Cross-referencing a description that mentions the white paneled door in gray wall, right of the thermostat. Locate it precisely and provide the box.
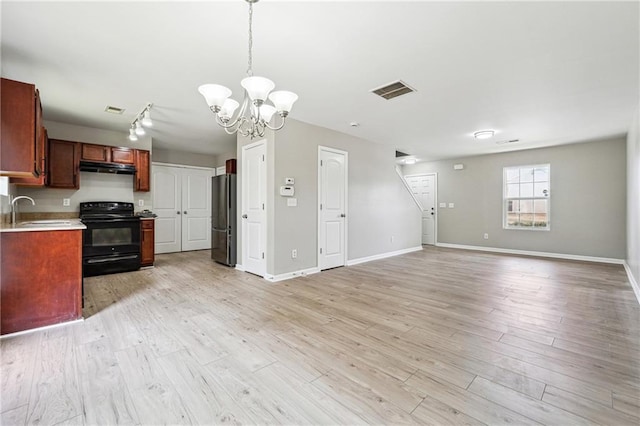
[318,147,348,270]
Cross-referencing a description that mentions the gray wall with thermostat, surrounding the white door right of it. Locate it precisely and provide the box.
[237,120,421,275]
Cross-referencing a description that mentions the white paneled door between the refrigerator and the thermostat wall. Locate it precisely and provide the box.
[242,141,267,276]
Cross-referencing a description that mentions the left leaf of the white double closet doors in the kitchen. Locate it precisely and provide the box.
[151,165,182,253]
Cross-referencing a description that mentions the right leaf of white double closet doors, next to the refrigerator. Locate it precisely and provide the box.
[182,168,214,251]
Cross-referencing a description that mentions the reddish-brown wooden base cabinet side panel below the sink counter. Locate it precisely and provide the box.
[0,230,82,334]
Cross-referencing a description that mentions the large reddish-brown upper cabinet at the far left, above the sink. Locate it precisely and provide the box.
[0,78,44,178]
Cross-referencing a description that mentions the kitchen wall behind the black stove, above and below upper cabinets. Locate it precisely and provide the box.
[11,121,155,213]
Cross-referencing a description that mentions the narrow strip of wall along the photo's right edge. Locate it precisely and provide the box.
[627,108,640,285]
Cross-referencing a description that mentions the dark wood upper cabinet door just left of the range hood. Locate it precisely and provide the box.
[47,139,81,189]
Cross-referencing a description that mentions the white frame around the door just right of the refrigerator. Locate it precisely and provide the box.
[241,138,269,278]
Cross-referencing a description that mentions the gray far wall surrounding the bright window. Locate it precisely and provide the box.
[402,138,627,259]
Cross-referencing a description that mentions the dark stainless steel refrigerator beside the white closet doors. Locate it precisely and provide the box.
[211,174,238,266]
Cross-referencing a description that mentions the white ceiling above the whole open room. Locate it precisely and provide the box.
[1,0,640,159]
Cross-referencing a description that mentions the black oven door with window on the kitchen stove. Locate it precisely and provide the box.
[82,217,140,258]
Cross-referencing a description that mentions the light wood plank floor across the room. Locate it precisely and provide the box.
[0,247,640,425]
